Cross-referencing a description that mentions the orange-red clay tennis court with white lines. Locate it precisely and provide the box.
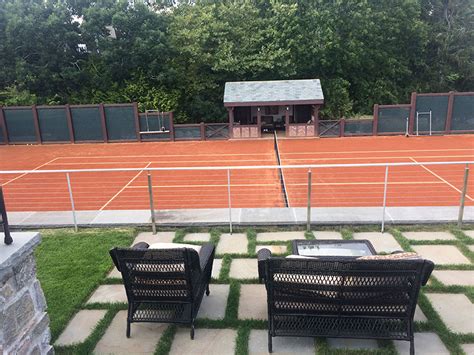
[0,135,474,211]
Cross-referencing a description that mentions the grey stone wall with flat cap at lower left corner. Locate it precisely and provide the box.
[0,233,54,354]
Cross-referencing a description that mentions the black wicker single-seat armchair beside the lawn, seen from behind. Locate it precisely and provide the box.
[110,242,215,339]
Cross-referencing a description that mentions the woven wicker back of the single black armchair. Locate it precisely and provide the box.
[111,248,201,302]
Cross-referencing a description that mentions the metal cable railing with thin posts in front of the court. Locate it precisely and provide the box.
[0,160,474,232]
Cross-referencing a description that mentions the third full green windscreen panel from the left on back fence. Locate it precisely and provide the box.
[71,107,104,142]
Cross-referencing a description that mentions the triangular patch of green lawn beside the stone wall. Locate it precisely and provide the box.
[35,229,135,341]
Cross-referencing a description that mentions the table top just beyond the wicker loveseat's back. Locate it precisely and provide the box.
[293,239,376,257]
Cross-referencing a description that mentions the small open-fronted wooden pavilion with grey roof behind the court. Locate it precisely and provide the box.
[224,79,324,138]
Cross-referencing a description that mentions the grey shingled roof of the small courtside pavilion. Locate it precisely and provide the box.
[224,79,324,106]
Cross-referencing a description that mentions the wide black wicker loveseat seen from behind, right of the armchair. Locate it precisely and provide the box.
[258,249,434,354]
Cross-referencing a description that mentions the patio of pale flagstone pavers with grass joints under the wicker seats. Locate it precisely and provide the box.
[51,231,474,355]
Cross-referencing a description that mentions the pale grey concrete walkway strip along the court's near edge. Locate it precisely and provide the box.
[8,206,474,228]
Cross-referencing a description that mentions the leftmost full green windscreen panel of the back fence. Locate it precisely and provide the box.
[3,108,36,143]
